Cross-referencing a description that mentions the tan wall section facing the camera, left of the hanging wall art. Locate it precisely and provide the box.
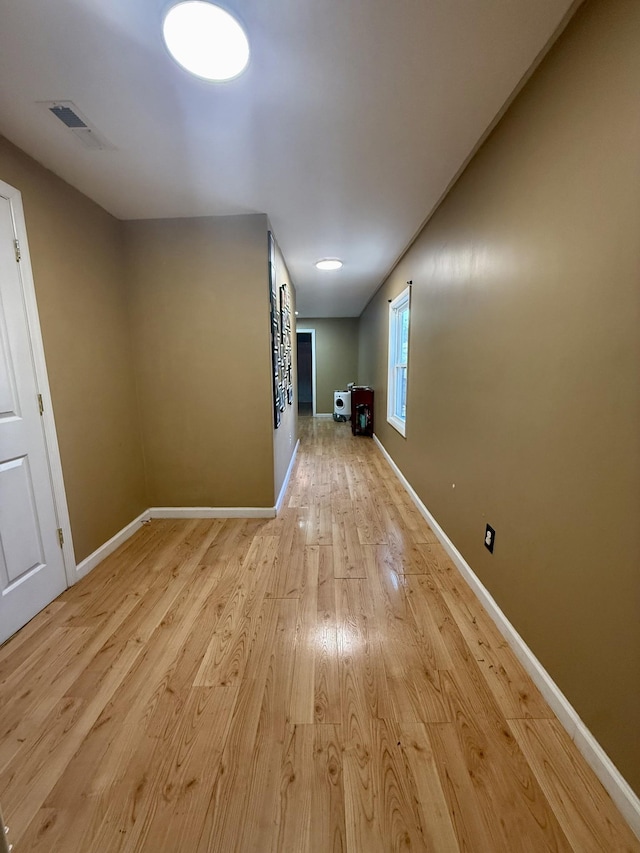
[125,215,274,507]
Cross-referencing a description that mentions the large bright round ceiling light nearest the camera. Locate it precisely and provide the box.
[162,0,249,81]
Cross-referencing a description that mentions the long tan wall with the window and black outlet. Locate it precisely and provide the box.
[359,0,640,793]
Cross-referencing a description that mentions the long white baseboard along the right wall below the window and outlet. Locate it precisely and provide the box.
[373,435,640,838]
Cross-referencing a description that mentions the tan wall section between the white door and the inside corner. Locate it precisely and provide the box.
[0,137,147,561]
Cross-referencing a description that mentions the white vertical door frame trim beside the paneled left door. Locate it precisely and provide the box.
[0,181,78,586]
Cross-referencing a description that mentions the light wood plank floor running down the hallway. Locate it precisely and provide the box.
[0,418,640,853]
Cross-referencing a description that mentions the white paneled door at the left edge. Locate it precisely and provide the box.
[0,194,67,642]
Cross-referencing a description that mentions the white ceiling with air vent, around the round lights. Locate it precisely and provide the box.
[0,0,572,317]
